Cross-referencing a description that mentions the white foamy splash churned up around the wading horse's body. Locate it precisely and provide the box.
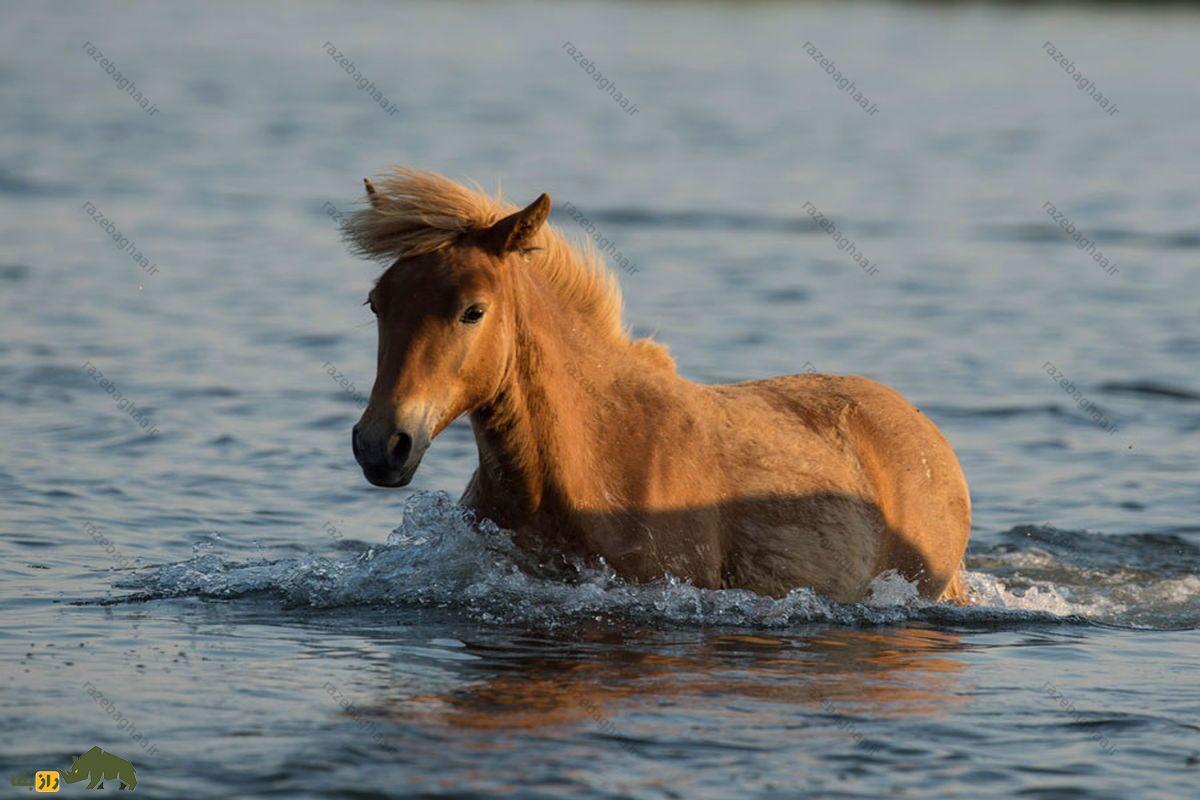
[108,492,1200,627]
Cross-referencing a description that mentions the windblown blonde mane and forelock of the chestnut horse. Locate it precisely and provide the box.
[343,167,674,366]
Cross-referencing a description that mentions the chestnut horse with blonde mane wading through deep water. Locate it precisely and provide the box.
[343,168,971,603]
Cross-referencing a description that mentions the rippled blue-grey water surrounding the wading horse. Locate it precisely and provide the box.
[0,2,1200,798]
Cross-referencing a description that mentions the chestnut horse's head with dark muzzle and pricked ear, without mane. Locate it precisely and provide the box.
[352,186,550,487]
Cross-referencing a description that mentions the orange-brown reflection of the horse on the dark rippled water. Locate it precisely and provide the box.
[417,628,964,728]
